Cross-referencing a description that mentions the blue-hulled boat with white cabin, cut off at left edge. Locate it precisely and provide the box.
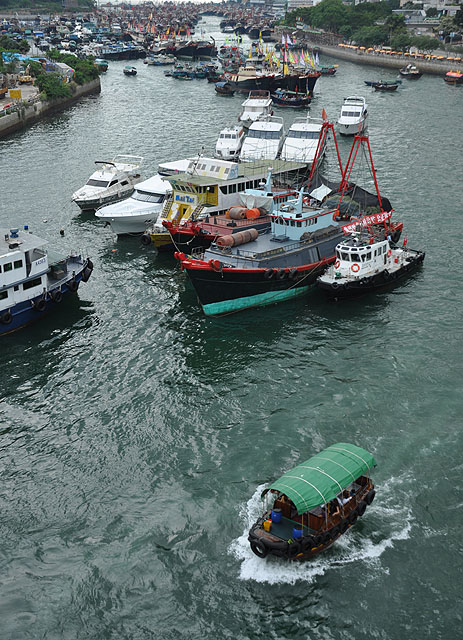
[0,226,93,334]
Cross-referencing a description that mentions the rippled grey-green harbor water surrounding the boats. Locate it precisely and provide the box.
[0,17,463,640]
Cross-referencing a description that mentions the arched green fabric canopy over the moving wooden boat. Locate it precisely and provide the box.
[268,442,376,514]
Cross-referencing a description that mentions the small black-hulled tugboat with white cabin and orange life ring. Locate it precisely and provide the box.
[317,225,425,300]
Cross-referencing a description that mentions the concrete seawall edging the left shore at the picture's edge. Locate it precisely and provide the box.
[0,78,101,139]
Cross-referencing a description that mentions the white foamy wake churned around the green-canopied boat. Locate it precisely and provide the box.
[229,478,412,584]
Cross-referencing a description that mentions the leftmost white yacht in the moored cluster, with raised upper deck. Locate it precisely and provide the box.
[72,155,143,210]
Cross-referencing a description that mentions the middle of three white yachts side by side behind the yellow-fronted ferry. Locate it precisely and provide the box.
[240,116,285,162]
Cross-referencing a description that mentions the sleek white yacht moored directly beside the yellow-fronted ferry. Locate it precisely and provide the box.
[95,174,171,235]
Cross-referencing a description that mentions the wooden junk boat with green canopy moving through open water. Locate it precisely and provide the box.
[248,442,376,560]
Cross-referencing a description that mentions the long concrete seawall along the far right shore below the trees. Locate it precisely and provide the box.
[307,42,463,76]
